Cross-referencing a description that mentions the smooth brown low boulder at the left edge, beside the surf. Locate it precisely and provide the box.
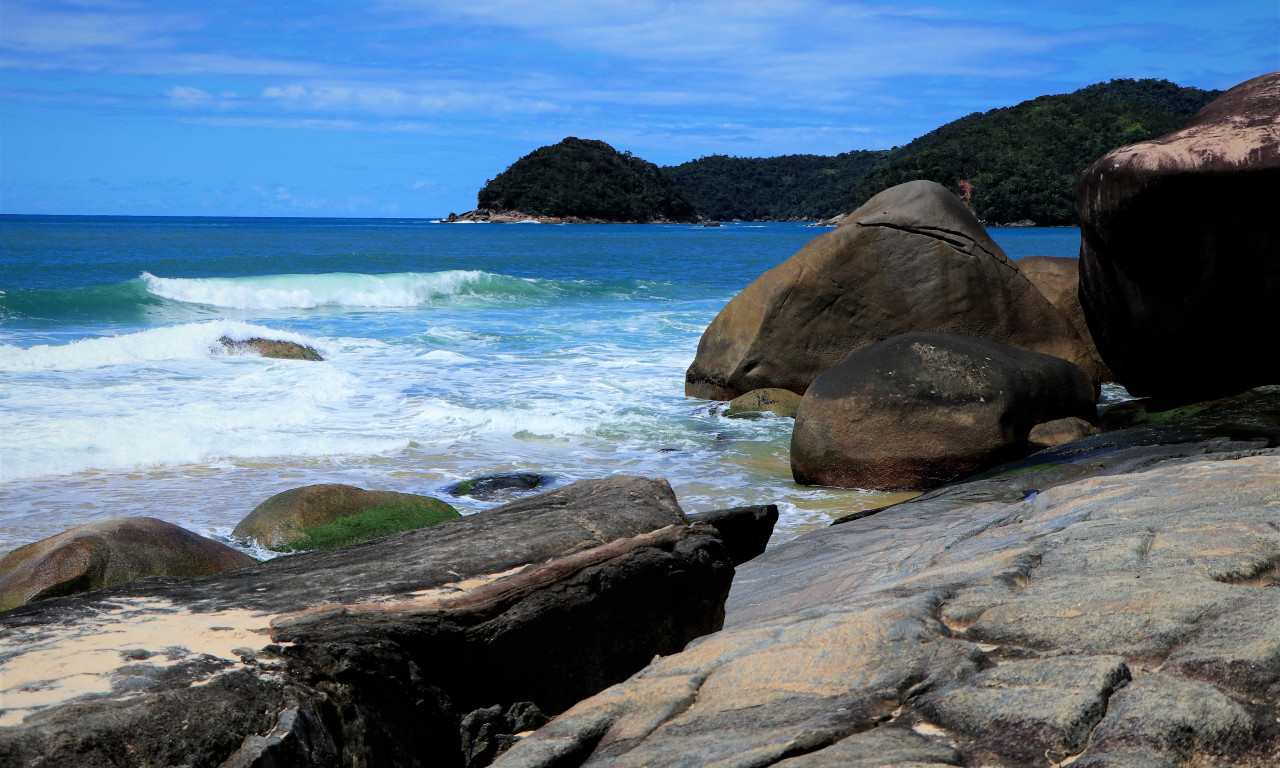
[0,517,257,611]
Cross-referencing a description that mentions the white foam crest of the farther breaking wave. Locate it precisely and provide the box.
[141,270,498,310]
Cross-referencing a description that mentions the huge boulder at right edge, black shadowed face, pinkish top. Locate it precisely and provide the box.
[1075,73,1280,402]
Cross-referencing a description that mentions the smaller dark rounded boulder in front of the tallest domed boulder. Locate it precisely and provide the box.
[791,333,1097,490]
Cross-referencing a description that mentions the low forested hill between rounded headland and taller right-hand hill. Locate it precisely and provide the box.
[663,150,883,221]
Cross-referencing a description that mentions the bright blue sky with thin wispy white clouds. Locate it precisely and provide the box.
[0,0,1280,216]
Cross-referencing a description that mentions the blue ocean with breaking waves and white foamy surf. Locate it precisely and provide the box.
[0,215,1079,556]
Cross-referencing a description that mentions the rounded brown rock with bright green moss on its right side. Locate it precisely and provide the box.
[232,484,460,552]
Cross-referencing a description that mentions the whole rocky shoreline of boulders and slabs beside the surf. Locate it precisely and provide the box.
[0,73,1280,768]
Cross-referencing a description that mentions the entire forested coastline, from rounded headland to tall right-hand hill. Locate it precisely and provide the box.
[454,79,1221,227]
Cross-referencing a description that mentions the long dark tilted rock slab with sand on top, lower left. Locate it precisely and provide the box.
[0,477,733,768]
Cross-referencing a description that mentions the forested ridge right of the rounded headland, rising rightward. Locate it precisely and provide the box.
[663,79,1219,225]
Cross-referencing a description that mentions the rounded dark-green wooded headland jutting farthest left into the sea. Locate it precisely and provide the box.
[477,137,694,221]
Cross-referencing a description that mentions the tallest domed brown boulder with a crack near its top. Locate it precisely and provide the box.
[685,180,1092,399]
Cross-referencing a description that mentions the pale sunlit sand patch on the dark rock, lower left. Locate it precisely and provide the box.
[0,598,279,724]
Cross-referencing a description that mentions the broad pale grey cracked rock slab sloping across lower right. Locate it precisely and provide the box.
[495,392,1280,768]
